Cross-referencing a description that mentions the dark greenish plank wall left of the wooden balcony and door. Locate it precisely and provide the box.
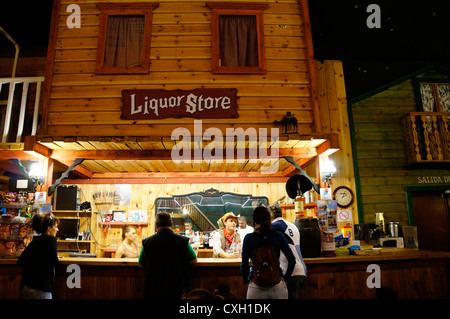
[351,80,448,225]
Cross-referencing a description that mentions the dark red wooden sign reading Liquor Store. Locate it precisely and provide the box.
[120,88,239,120]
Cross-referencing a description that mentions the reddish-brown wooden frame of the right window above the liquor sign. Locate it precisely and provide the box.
[206,2,269,74]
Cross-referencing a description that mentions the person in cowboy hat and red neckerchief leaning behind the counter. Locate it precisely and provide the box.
[212,213,241,258]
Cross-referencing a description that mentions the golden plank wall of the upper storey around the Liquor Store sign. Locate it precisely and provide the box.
[44,0,314,136]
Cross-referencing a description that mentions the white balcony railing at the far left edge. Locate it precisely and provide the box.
[0,77,44,143]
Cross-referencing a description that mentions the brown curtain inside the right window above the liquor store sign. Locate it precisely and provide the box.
[219,15,258,67]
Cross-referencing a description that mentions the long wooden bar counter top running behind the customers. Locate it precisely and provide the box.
[0,248,450,267]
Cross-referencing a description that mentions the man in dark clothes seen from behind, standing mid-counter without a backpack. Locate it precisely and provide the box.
[139,212,197,299]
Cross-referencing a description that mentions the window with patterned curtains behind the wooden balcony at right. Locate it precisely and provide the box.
[419,81,450,112]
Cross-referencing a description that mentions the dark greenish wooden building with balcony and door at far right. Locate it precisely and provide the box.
[349,65,450,251]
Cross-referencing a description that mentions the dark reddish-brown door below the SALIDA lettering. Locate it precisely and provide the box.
[411,191,450,251]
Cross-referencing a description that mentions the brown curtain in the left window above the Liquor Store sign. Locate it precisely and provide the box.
[103,15,145,68]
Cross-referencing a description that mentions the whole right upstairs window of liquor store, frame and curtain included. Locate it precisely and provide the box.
[206,2,268,74]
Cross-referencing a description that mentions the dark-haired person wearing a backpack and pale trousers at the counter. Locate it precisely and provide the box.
[241,206,295,299]
